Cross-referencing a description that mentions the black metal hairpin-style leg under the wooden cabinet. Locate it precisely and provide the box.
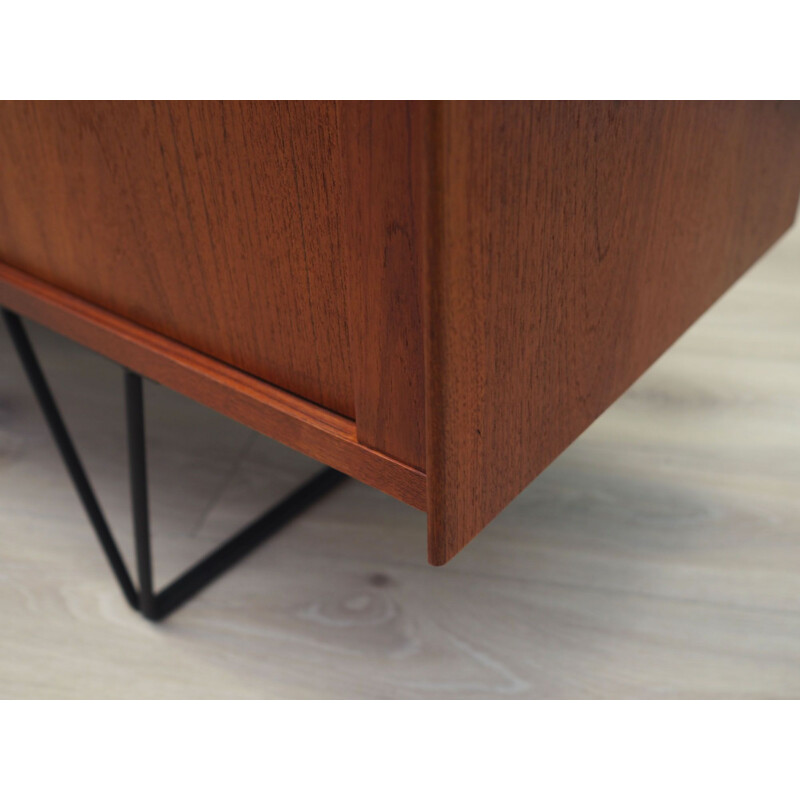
[2,309,346,620]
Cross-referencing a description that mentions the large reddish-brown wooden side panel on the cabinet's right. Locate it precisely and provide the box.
[426,102,800,564]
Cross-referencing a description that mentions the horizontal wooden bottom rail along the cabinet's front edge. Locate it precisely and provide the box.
[0,263,427,511]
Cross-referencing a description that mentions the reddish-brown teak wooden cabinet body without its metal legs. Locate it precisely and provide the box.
[0,102,800,564]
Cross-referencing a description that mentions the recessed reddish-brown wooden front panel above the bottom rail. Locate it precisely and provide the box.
[0,102,354,418]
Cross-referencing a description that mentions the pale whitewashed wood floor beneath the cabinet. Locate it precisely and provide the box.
[0,222,800,698]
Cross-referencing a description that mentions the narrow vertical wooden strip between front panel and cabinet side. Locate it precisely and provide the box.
[337,102,428,469]
